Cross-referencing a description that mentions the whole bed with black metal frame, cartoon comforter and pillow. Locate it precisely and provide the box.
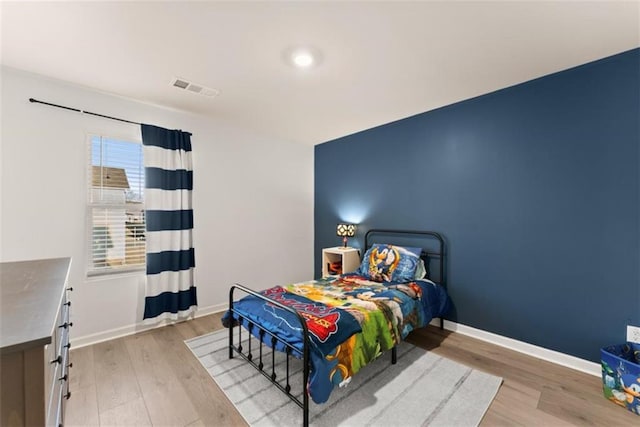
[222,229,450,426]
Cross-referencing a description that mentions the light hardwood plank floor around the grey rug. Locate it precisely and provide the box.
[65,314,640,427]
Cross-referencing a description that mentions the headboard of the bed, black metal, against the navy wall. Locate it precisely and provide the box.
[362,229,447,288]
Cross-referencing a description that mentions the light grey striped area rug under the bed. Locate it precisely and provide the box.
[185,329,502,427]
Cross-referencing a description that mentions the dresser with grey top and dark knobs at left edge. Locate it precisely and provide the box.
[0,258,73,427]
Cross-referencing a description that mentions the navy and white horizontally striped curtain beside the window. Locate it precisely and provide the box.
[142,124,197,319]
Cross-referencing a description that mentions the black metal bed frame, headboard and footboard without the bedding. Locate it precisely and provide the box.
[229,229,446,427]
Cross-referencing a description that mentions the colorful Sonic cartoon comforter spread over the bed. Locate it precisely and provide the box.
[223,274,449,403]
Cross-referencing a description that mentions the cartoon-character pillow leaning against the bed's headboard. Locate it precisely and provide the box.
[358,243,422,282]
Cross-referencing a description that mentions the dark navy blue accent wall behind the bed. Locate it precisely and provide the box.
[315,49,640,361]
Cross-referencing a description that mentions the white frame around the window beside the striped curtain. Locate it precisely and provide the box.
[84,132,146,279]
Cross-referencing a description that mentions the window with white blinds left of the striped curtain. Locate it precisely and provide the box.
[87,136,146,275]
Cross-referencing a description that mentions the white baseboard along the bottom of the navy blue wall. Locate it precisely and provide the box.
[431,319,602,377]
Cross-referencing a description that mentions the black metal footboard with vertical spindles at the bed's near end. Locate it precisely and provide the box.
[229,283,309,427]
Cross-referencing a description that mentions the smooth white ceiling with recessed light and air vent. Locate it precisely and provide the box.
[0,0,640,144]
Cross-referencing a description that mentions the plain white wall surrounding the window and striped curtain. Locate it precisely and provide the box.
[0,67,313,343]
